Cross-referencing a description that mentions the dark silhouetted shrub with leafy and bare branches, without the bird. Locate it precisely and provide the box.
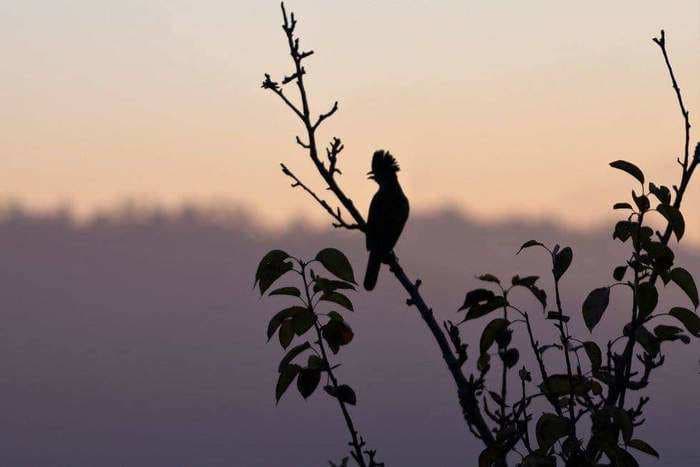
[255,4,700,467]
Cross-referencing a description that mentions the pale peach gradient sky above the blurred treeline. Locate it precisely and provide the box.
[0,0,700,240]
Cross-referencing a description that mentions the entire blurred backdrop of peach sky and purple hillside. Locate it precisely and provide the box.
[0,0,700,466]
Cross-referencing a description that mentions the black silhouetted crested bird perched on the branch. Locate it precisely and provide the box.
[364,150,409,290]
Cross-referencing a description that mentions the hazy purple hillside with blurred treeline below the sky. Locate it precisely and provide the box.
[0,207,700,467]
